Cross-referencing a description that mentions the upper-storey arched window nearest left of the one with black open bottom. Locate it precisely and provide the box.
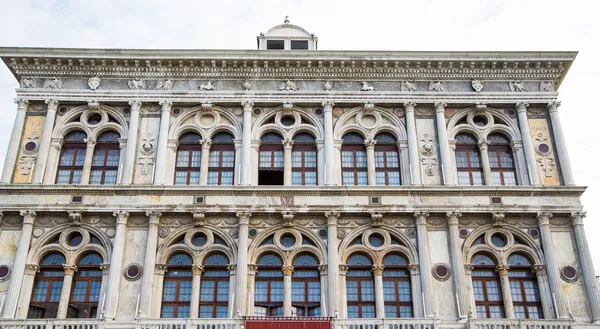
[208,133,235,185]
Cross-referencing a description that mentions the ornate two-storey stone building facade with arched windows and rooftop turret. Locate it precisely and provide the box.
[0,19,600,329]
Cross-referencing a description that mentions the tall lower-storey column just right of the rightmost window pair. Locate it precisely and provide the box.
[537,211,567,319]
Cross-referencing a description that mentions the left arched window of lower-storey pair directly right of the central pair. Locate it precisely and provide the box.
[346,254,375,318]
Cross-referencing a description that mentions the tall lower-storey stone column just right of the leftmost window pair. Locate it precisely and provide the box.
[104,210,129,319]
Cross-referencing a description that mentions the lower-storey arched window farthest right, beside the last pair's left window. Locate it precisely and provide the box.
[507,254,544,319]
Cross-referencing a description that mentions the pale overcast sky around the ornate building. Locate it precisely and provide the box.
[0,0,600,270]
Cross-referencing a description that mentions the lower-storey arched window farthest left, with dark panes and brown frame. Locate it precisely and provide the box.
[27,252,67,319]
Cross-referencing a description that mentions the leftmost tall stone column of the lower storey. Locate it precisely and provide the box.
[2,210,36,319]
